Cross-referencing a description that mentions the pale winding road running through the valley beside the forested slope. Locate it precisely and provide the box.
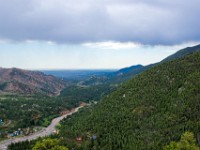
[0,106,83,150]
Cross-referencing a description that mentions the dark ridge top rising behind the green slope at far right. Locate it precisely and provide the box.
[161,44,200,62]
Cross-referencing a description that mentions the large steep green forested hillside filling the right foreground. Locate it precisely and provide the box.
[59,52,200,150]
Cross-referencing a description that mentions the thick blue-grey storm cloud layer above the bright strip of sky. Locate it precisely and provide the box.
[0,0,200,45]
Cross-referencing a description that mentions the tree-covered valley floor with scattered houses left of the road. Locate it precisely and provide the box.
[0,95,80,141]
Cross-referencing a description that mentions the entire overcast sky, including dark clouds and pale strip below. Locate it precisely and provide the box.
[0,0,200,69]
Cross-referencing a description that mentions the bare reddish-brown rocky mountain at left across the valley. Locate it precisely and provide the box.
[0,68,66,96]
